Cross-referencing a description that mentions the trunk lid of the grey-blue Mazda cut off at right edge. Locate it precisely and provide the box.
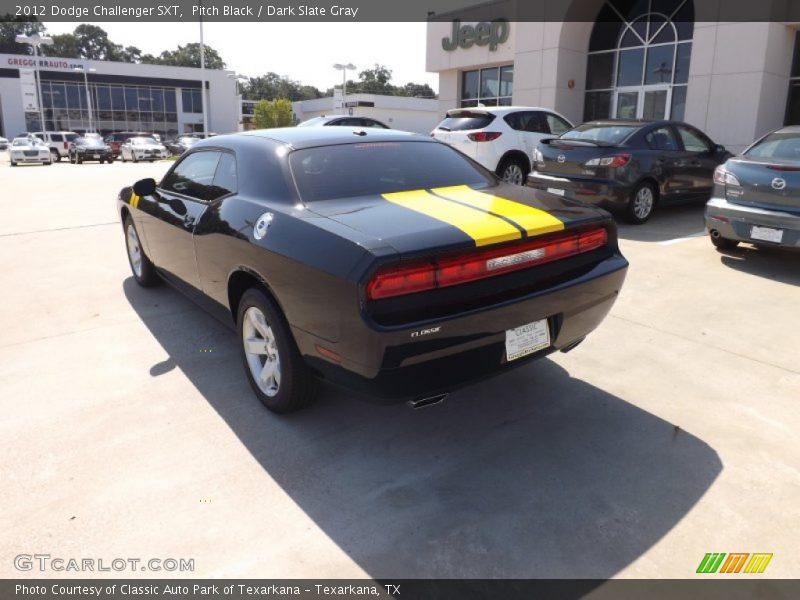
[725,156,800,212]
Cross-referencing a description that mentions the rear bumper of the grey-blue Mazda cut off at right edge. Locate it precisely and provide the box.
[706,198,800,249]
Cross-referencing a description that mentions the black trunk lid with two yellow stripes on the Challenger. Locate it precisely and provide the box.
[308,183,610,256]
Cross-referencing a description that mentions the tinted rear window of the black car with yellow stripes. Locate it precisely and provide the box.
[289,142,490,202]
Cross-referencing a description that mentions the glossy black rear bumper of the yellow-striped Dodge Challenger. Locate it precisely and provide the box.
[293,254,628,404]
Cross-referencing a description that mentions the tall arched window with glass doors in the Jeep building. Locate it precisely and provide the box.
[583,0,694,121]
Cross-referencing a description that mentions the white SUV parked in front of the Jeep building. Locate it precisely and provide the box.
[431,106,573,185]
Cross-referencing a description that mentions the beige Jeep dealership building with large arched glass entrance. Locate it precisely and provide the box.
[426,0,800,151]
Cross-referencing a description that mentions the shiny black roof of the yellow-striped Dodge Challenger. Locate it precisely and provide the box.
[216,127,438,149]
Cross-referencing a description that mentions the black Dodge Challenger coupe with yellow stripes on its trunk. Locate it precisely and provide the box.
[118,127,628,412]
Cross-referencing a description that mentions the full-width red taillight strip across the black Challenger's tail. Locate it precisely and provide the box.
[367,228,608,300]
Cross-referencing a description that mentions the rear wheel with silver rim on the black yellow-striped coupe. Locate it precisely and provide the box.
[236,288,318,414]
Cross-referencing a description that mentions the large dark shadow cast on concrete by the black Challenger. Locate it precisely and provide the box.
[123,278,722,579]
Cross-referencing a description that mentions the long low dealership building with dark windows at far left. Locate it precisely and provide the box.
[0,54,241,138]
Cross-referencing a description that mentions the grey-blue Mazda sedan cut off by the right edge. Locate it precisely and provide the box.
[706,126,800,249]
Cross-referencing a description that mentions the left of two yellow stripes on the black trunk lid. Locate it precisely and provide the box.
[383,190,520,246]
